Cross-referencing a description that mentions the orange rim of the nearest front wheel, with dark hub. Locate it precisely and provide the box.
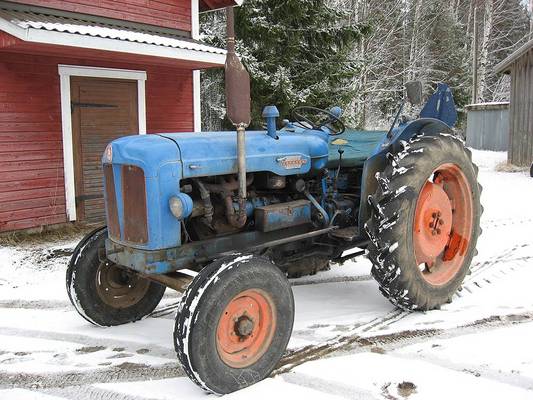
[216,289,276,368]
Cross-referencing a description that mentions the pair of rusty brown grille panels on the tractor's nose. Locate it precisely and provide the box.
[104,164,148,244]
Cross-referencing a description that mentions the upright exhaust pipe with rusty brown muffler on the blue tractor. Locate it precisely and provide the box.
[225,7,251,228]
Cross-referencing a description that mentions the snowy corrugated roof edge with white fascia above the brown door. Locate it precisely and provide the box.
[0,8,226,63]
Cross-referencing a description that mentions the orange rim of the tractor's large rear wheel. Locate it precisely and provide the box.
[413,164,473,286]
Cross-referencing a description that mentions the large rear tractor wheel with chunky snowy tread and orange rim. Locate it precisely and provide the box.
[365,134,483,310]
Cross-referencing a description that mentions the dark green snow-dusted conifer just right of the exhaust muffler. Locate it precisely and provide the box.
[198,0,366,127]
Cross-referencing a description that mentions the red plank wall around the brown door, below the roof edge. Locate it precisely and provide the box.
[0,52,193,231]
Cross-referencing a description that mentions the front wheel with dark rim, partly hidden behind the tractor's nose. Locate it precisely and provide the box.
[67,228,166,326]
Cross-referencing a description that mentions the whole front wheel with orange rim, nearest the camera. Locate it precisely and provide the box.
[174,255,294,394]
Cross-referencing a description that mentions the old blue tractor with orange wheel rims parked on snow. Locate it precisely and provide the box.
[67,5,482,394]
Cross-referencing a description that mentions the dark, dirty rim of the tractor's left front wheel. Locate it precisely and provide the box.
[96,261,150,308]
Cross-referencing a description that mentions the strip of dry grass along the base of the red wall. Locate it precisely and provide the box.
[0,224,97,246]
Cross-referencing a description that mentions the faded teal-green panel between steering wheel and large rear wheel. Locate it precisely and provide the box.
[328,129,387,168]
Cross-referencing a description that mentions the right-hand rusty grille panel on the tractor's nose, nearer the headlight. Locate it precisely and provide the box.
[122,165,148,244]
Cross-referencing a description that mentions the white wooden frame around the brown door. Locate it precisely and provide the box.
[58,64,146,221]
